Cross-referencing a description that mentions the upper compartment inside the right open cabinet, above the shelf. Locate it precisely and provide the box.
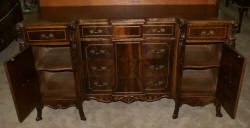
[184,44,222,69]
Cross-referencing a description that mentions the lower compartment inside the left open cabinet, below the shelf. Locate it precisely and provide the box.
[39,71,76,99]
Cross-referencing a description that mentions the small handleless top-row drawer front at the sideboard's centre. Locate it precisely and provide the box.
[112,26,142,38]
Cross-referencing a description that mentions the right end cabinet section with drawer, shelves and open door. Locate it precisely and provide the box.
[173,21,246,118]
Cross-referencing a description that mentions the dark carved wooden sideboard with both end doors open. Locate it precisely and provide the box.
[4,0,246,122]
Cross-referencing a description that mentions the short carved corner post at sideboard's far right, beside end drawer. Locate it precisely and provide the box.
[227,22,239,48]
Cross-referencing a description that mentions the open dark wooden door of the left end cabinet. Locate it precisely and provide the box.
[4,48,40,122]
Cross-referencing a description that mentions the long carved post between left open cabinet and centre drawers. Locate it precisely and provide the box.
[69,23,86,120]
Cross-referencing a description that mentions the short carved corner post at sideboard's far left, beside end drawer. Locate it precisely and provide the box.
[16,23,28,51]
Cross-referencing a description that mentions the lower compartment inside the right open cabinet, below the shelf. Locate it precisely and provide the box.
[181,69,218,95]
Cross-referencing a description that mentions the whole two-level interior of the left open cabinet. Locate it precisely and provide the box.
[32,46,76,99]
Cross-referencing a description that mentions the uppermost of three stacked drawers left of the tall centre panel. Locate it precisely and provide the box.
[85,44,114,60]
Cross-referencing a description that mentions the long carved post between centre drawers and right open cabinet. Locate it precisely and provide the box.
[172,19,186,119]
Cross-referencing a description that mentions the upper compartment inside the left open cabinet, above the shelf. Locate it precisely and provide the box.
[35,47,72,71]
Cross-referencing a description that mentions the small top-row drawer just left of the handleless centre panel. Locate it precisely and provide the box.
[81,26,112,37]
